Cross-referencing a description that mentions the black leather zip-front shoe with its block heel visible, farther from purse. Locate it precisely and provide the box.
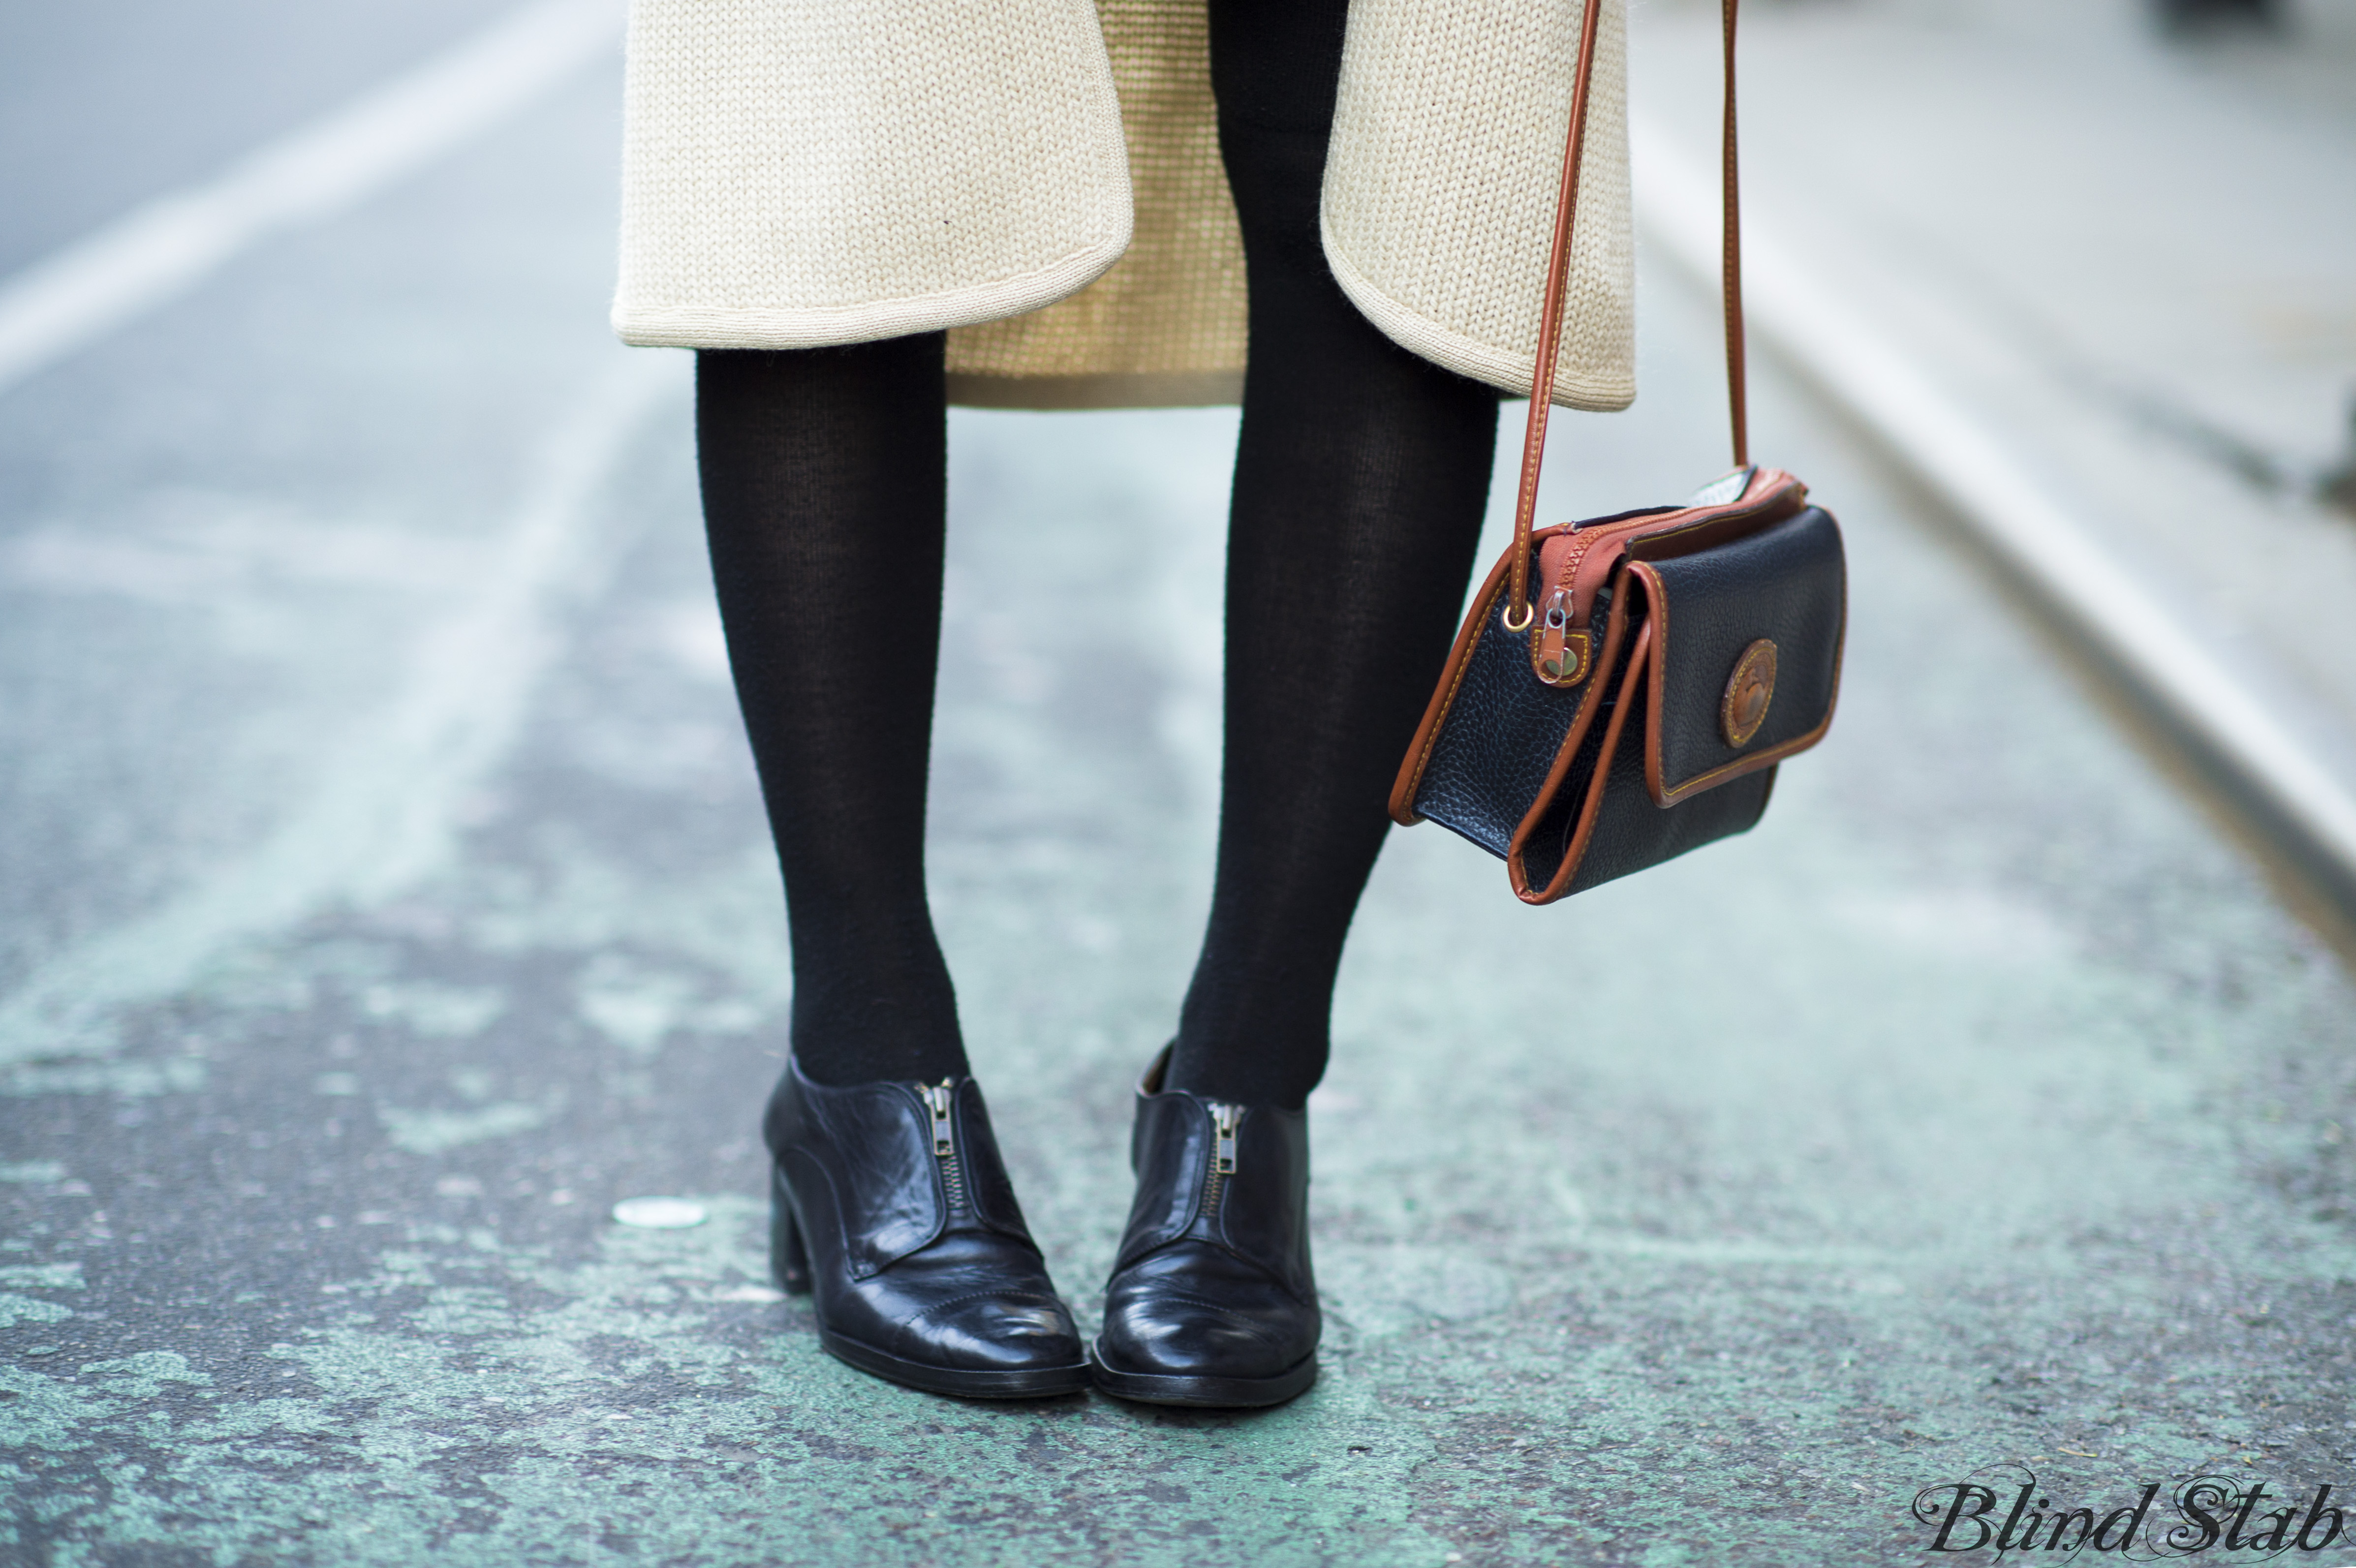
[763,1059,1088,1398]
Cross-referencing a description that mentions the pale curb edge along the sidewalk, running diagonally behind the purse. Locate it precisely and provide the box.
[1628,123,2356,914]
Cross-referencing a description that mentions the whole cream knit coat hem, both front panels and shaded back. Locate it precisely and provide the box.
[613,0,1635,410]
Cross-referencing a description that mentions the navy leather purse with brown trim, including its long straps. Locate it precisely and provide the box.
[1390,0,1847,904]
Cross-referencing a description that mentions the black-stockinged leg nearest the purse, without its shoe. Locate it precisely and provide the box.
[1171,0,1496,1107]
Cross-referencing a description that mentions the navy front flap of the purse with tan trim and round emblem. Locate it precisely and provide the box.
[1628,506,1847,805]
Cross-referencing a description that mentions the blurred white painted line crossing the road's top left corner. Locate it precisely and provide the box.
[0,0,620,391]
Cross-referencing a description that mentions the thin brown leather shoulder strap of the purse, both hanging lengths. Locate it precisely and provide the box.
[1506,0,1750,631]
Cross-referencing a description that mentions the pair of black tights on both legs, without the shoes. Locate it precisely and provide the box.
[697,0,1496,1104]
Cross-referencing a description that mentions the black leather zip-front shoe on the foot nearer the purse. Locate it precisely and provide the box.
[1095,1050,1319,1406]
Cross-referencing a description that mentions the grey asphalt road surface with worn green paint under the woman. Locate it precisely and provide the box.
[0,7,2356,1568]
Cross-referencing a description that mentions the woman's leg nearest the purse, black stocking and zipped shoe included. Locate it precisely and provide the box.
[1095,0,1496,1406]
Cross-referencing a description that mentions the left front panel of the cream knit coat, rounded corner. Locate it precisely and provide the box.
[613,0,1131,348]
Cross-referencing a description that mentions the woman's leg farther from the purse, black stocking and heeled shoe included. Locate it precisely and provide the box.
[695,332,1088,1398]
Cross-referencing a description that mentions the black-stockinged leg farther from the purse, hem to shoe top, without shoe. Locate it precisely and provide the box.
[695,332,966,1083]
